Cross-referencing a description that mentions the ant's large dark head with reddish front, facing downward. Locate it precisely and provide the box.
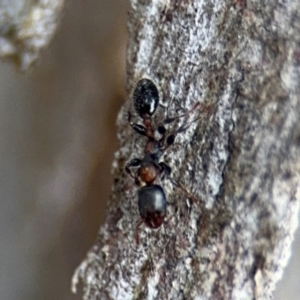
[138,185,167,228]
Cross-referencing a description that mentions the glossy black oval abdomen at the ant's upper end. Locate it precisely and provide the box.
[133,78,159,118]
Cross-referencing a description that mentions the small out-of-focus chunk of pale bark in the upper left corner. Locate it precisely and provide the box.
[0,0,64,71]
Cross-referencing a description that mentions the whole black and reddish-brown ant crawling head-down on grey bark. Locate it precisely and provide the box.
[125,78,200,228]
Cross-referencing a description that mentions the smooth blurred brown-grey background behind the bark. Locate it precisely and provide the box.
[0,0,300,300]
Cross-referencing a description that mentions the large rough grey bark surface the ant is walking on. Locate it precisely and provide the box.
[73,0,300,300]
